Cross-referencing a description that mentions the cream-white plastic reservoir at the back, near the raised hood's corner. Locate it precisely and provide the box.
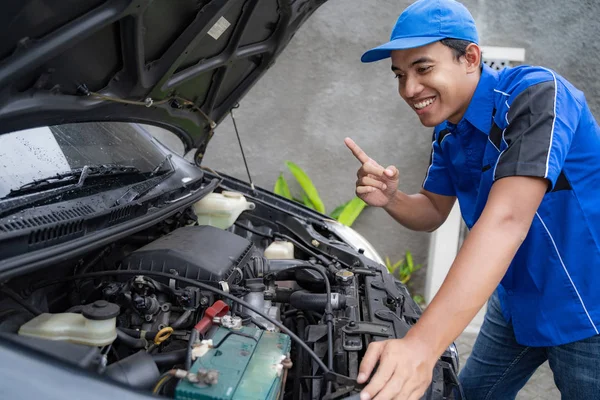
[194,191,255,229]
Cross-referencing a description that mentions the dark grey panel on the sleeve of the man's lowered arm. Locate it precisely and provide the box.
[495,80,556,179]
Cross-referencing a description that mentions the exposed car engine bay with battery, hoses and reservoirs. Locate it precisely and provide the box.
[0,186,458,400]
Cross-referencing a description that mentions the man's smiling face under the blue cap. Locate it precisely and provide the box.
[392,42,481,127]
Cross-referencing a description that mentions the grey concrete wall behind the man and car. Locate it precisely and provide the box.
[197,0,600,292]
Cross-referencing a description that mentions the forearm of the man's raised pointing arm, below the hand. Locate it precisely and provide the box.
[383,190,446,232]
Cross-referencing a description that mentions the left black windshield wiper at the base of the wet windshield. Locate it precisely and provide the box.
[3,164,142,199]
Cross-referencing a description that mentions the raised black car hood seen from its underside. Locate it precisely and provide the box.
[0,0,326,163]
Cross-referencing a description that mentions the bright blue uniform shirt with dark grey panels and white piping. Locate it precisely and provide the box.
[423,65,600,346]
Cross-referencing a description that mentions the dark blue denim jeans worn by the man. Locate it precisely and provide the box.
[459,293,600,400]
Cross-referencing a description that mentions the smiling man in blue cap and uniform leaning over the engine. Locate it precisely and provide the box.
[346,0,600,400]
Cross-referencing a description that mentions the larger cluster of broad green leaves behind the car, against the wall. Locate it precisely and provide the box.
[273,161,367,226]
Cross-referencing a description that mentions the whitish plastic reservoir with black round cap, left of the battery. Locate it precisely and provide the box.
[19,300,119,346]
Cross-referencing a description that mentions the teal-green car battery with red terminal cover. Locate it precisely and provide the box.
[175,326,291,400]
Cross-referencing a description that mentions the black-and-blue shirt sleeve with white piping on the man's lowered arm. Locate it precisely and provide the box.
[494,73,582,191]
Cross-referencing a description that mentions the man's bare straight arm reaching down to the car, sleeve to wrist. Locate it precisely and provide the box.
[407,177,546,356]
